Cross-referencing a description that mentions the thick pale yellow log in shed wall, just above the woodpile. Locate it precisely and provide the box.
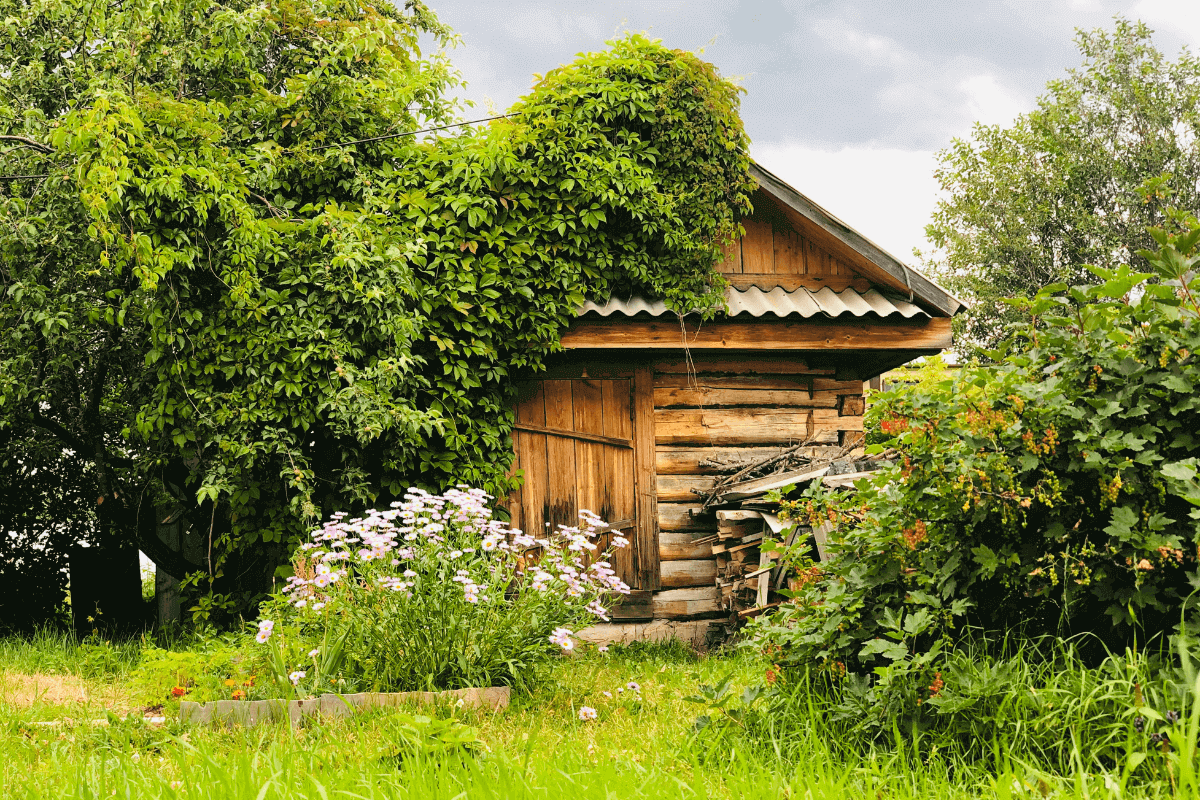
[654,408,816,445]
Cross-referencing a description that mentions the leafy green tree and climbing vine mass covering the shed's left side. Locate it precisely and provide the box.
[0,0,751,623]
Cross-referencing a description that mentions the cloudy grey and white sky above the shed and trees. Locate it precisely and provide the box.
[430,0,1200,263]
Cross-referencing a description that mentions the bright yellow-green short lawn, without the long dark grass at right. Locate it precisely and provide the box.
[0,637,1190,800]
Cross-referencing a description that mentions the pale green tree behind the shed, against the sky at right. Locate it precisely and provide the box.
[926,19,1200,348]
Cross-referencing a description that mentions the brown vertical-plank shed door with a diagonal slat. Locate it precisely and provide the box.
[509,375,658,589]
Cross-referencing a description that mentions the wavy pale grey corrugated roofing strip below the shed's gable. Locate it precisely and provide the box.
[578,287,929,319]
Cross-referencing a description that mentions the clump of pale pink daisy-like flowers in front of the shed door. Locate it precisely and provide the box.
[257,488,629,692]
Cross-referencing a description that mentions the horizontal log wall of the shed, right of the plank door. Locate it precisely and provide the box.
[653,353,863,619]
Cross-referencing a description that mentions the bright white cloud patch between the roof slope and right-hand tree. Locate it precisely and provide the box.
[751,143,938,264]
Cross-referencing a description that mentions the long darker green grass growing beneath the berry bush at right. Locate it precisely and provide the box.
[746,637,1200,790]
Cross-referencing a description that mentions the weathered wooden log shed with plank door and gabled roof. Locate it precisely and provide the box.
[509,166,961,642]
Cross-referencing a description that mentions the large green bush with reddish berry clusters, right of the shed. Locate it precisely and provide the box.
[754,221,1200,676]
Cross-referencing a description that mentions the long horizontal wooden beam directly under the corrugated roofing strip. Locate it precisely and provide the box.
[562,317,953,350]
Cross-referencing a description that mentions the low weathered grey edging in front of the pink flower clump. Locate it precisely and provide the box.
[179,686,512,728]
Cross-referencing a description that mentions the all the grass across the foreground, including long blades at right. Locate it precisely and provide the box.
[0,636,1200,800]
